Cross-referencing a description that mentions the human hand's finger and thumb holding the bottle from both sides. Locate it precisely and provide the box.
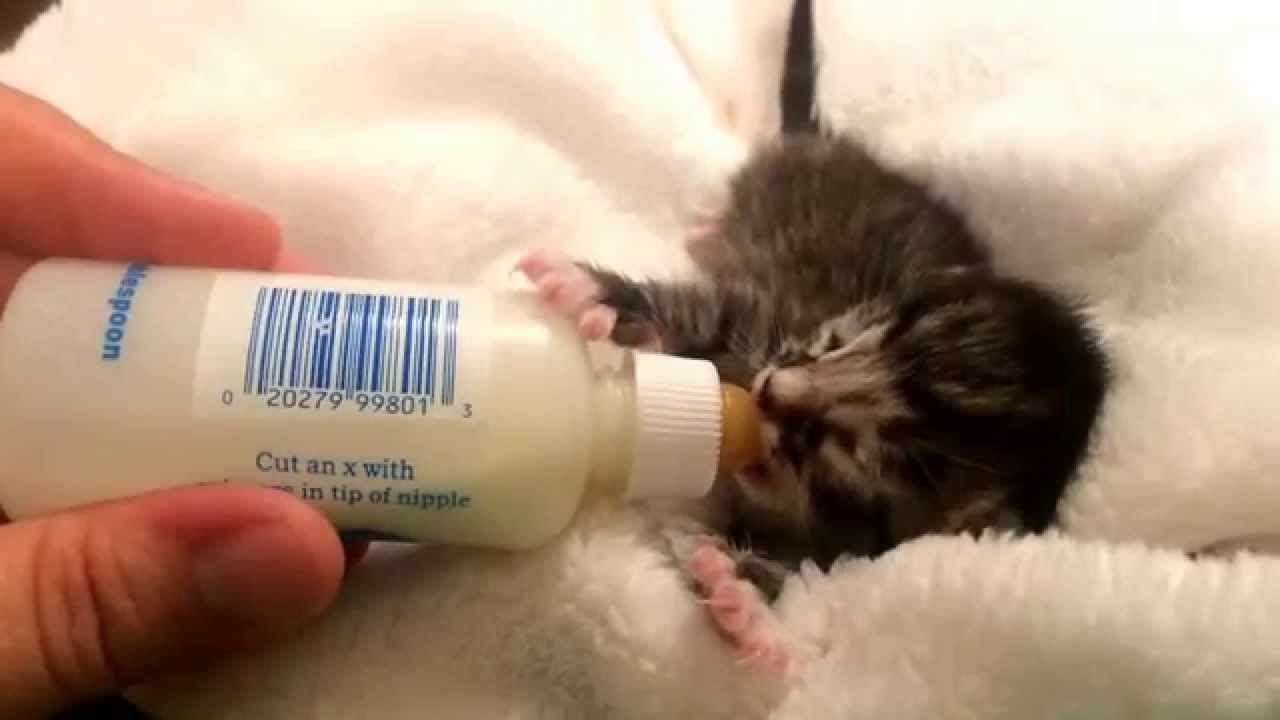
[0,86,343,717]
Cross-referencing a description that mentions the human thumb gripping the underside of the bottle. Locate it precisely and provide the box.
[0,487,343,717]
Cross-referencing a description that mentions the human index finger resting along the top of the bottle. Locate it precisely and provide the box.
[0,86,280,269]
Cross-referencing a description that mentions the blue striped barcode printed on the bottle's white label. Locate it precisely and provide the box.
[244,287,461,405]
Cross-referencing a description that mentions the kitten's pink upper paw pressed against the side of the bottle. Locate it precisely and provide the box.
[516,250,618,340]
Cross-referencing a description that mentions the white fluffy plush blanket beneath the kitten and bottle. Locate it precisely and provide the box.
[0,0,1280,720]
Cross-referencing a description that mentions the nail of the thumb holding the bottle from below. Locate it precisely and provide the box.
[193,523,328,626]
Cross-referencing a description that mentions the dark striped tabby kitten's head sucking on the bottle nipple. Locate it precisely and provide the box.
[733,272,1107,564]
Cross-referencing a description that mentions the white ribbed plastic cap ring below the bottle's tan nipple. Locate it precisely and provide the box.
[626,352,721,500]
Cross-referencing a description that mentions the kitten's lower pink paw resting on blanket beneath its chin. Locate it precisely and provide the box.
[689,541,792,674]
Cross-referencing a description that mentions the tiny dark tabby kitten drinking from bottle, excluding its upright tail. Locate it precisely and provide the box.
[521,135,1108,655]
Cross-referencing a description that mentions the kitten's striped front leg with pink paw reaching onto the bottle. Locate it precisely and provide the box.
[516,250,732,356]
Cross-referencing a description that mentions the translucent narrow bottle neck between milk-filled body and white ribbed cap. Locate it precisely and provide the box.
[590,352,636,500]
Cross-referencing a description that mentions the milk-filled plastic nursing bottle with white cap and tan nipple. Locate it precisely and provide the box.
[0,260,759,548]
